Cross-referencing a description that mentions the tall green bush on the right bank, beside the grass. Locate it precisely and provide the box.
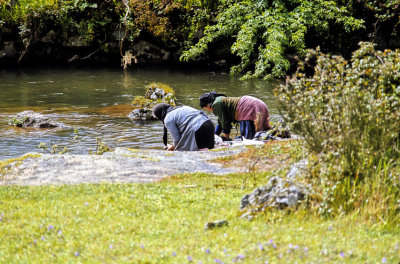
[277,43,400,226]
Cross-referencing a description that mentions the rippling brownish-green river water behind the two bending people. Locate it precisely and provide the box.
[0,68,279,160]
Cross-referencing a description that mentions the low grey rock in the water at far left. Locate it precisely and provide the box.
[8,110,65,128]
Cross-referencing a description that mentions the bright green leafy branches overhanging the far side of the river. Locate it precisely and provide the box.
[181,0,362,77]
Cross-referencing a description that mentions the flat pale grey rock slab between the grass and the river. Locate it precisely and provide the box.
[0,147,244,186]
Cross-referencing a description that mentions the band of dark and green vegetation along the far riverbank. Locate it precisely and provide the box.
[0,0,400,77]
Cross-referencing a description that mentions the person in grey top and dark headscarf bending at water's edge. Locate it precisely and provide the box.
[153,103,215,151]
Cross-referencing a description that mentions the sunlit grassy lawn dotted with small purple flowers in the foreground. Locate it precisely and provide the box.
[0,141,400,264]
